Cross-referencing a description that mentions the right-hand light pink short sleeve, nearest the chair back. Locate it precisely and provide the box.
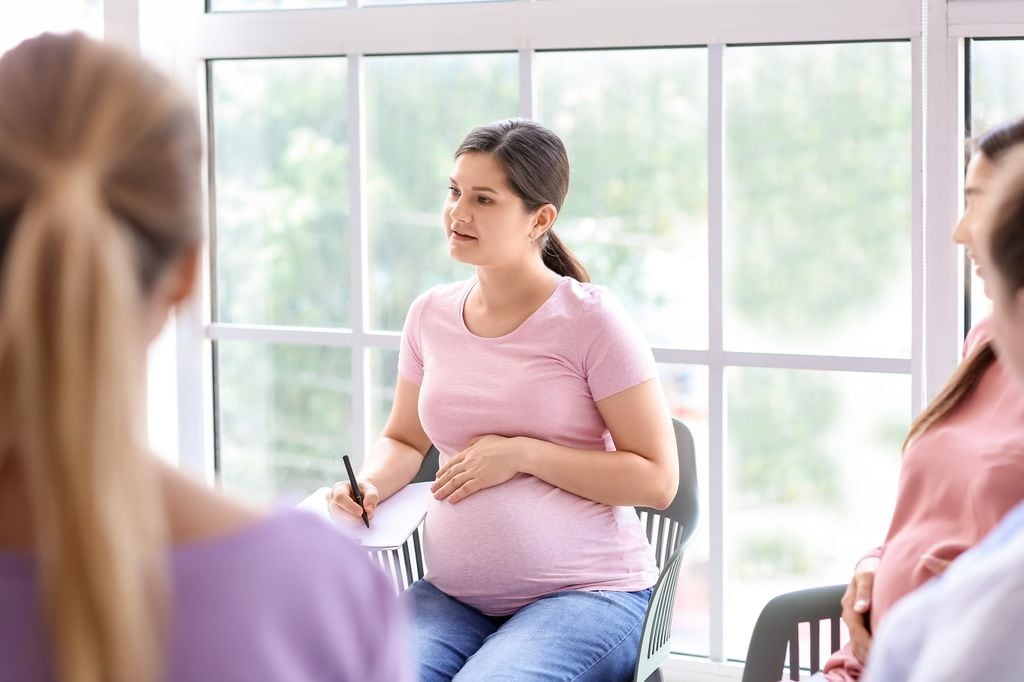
[577,287,657,401]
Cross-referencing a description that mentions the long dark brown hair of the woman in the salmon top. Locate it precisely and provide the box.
[903,118,1024,450]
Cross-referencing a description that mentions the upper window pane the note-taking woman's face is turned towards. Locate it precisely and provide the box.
[365,53,519,330]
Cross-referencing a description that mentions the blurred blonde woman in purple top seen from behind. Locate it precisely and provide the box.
[0,34,408,682]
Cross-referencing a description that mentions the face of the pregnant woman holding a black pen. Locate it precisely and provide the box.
[442,152,539,266]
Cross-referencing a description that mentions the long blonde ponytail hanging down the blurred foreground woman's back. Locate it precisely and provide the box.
[0,168,166,682]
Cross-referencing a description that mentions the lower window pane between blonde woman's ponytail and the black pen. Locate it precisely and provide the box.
[217,341,352,504]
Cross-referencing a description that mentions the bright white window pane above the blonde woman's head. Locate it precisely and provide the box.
[0,0,103,54]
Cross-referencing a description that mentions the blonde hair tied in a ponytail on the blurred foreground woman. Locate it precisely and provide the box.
[0,34,202,682]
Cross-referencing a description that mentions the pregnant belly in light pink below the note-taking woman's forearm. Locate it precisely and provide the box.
[424,474,652,614]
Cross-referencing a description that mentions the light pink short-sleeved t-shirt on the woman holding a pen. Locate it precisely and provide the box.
[398,278,657,615]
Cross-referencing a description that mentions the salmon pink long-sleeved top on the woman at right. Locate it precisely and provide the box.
[824,321,1024,682]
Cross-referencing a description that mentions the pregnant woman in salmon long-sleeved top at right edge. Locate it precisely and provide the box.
[822,119,1024,682]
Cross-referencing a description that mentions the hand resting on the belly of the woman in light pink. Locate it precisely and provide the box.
[430,435,521,504]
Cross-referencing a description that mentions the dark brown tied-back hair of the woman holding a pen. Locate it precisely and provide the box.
[455,119,590,282]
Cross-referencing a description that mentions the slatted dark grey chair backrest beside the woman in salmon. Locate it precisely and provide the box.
[742,585,846,682]
